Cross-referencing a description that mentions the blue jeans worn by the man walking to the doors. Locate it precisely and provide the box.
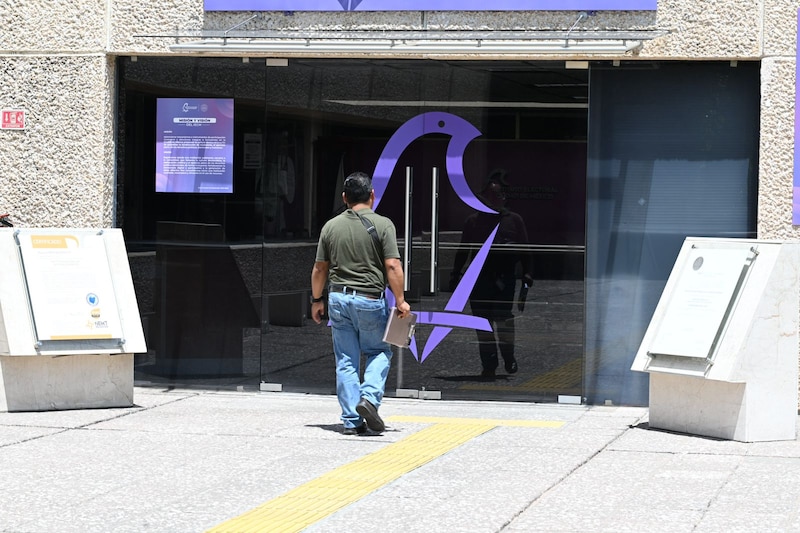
[328,292,392,428]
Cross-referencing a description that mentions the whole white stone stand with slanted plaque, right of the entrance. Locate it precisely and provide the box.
[631,238,800,442]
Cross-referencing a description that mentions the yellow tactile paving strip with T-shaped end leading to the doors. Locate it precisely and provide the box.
[208,416,564,533]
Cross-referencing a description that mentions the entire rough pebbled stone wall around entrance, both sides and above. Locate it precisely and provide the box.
[0,0,800,400]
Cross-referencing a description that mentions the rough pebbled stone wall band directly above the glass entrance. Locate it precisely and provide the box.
[110,0,764,59]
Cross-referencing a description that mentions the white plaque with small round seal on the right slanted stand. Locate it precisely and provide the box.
[648,248,754,358]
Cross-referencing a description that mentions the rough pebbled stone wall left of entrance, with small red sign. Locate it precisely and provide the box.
[0,0,114,227]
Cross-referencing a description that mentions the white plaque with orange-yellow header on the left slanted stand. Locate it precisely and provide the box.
[18,230,122,341]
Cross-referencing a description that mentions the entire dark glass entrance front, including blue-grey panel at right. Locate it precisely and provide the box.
[117,57,758,403]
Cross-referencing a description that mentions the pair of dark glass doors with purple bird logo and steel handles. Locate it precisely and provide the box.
[261,59,588,400]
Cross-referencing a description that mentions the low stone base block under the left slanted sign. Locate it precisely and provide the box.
[0,354,133,412]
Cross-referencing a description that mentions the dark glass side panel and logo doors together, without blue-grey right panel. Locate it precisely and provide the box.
[119,58,588,401]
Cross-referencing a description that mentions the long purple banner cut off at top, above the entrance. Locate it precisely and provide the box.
[205,0,658,11]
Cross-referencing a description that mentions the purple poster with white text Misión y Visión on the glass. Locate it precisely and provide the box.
[155,98,233,193]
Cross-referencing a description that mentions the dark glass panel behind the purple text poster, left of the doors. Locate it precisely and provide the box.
[117,58,268,383]
